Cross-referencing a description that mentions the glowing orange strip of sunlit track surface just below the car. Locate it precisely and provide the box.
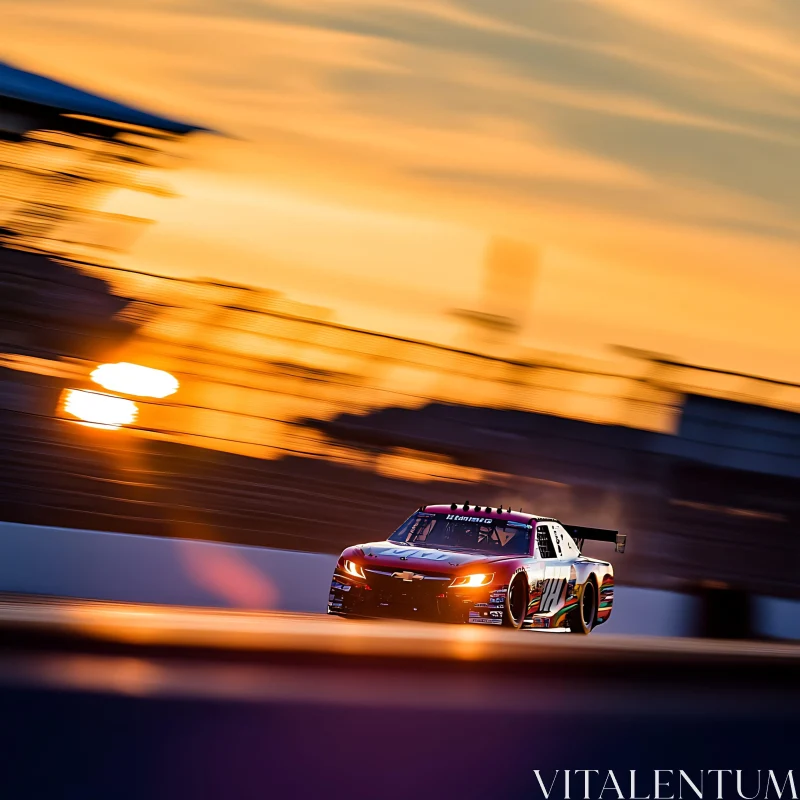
[0,596,800,666]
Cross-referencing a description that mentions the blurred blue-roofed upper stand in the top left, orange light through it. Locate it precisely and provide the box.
[0,62,200,261]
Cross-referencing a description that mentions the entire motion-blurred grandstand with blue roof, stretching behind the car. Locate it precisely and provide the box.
[0,65,800,620]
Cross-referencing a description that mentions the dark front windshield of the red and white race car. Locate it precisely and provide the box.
[389,512,532,555]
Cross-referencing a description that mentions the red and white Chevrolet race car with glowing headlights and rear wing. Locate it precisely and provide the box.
[328,503,626,635]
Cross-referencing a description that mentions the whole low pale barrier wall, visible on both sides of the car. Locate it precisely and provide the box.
[0,522,800,638]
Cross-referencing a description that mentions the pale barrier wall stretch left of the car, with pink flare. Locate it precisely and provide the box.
[0,522,336,612]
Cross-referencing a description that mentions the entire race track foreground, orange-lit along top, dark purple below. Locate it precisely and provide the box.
[0,597,800,800]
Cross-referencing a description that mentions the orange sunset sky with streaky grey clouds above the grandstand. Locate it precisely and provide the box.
[0,0,800,381]
